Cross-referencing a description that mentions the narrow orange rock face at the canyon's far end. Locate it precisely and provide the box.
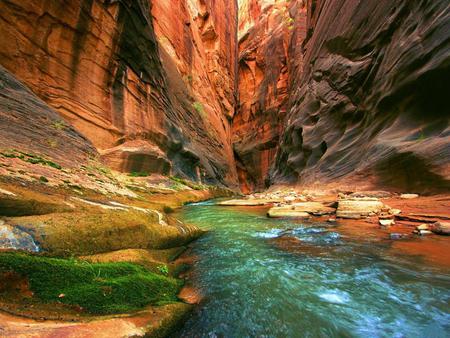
[233,0,306,192]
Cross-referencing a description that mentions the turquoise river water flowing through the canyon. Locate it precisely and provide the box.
[177,202,450,338]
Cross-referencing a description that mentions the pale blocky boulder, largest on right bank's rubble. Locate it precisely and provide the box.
[336,198,386,219]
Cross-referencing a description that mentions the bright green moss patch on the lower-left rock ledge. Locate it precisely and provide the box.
[0,252,181,314]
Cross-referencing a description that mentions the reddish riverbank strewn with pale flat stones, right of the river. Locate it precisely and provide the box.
[219,187,450,267]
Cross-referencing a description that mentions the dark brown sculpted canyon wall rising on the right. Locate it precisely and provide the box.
[272,0,450,191]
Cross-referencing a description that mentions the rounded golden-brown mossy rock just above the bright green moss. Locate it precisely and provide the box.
[8,208,202,256]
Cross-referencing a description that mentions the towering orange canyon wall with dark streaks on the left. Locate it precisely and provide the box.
[0,0,237,186]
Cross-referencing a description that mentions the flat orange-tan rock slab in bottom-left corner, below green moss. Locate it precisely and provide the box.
[0,303,191,338]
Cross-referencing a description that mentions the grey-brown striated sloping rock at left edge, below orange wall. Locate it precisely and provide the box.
[0,66,98,167]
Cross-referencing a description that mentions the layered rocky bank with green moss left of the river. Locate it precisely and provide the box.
[0,150,229,337]
